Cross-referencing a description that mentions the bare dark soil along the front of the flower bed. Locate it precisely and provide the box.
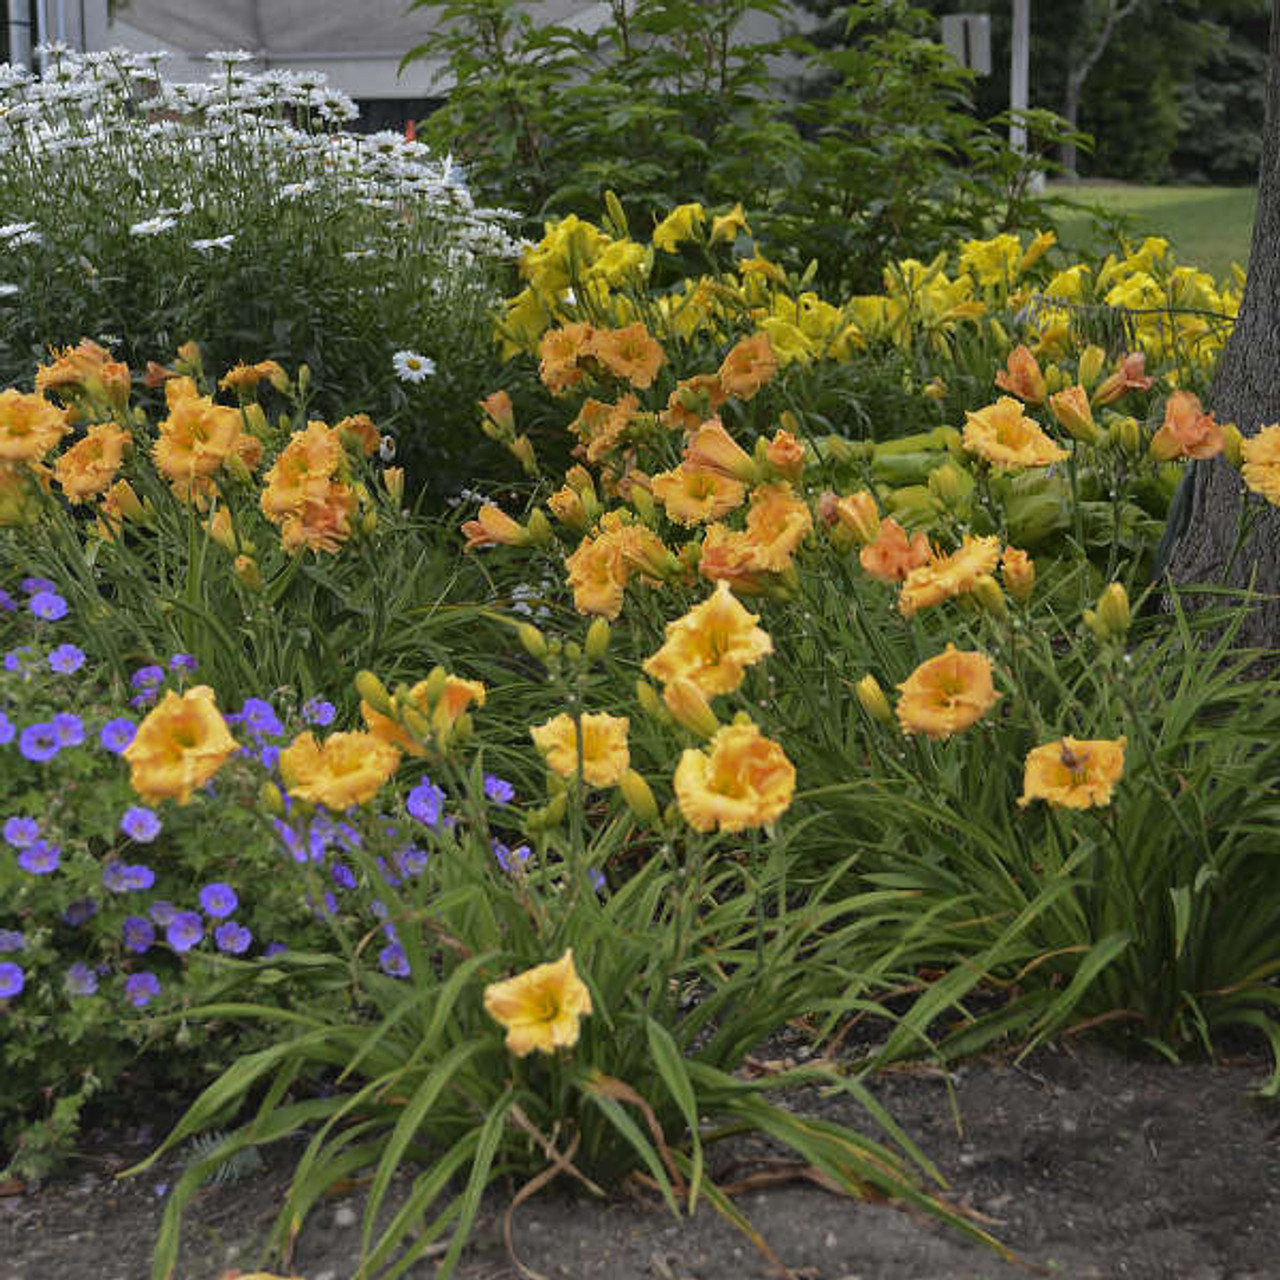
[0,1048,1280,1280]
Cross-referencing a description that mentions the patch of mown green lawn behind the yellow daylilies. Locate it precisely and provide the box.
[1050,183,1257,279]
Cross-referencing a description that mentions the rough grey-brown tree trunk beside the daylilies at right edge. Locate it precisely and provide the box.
[1167,0,1280,648]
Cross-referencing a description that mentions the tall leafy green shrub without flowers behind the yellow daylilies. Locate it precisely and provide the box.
[408,0,1053,292]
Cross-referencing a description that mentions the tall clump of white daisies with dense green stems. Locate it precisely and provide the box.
[0,45,524,500]
